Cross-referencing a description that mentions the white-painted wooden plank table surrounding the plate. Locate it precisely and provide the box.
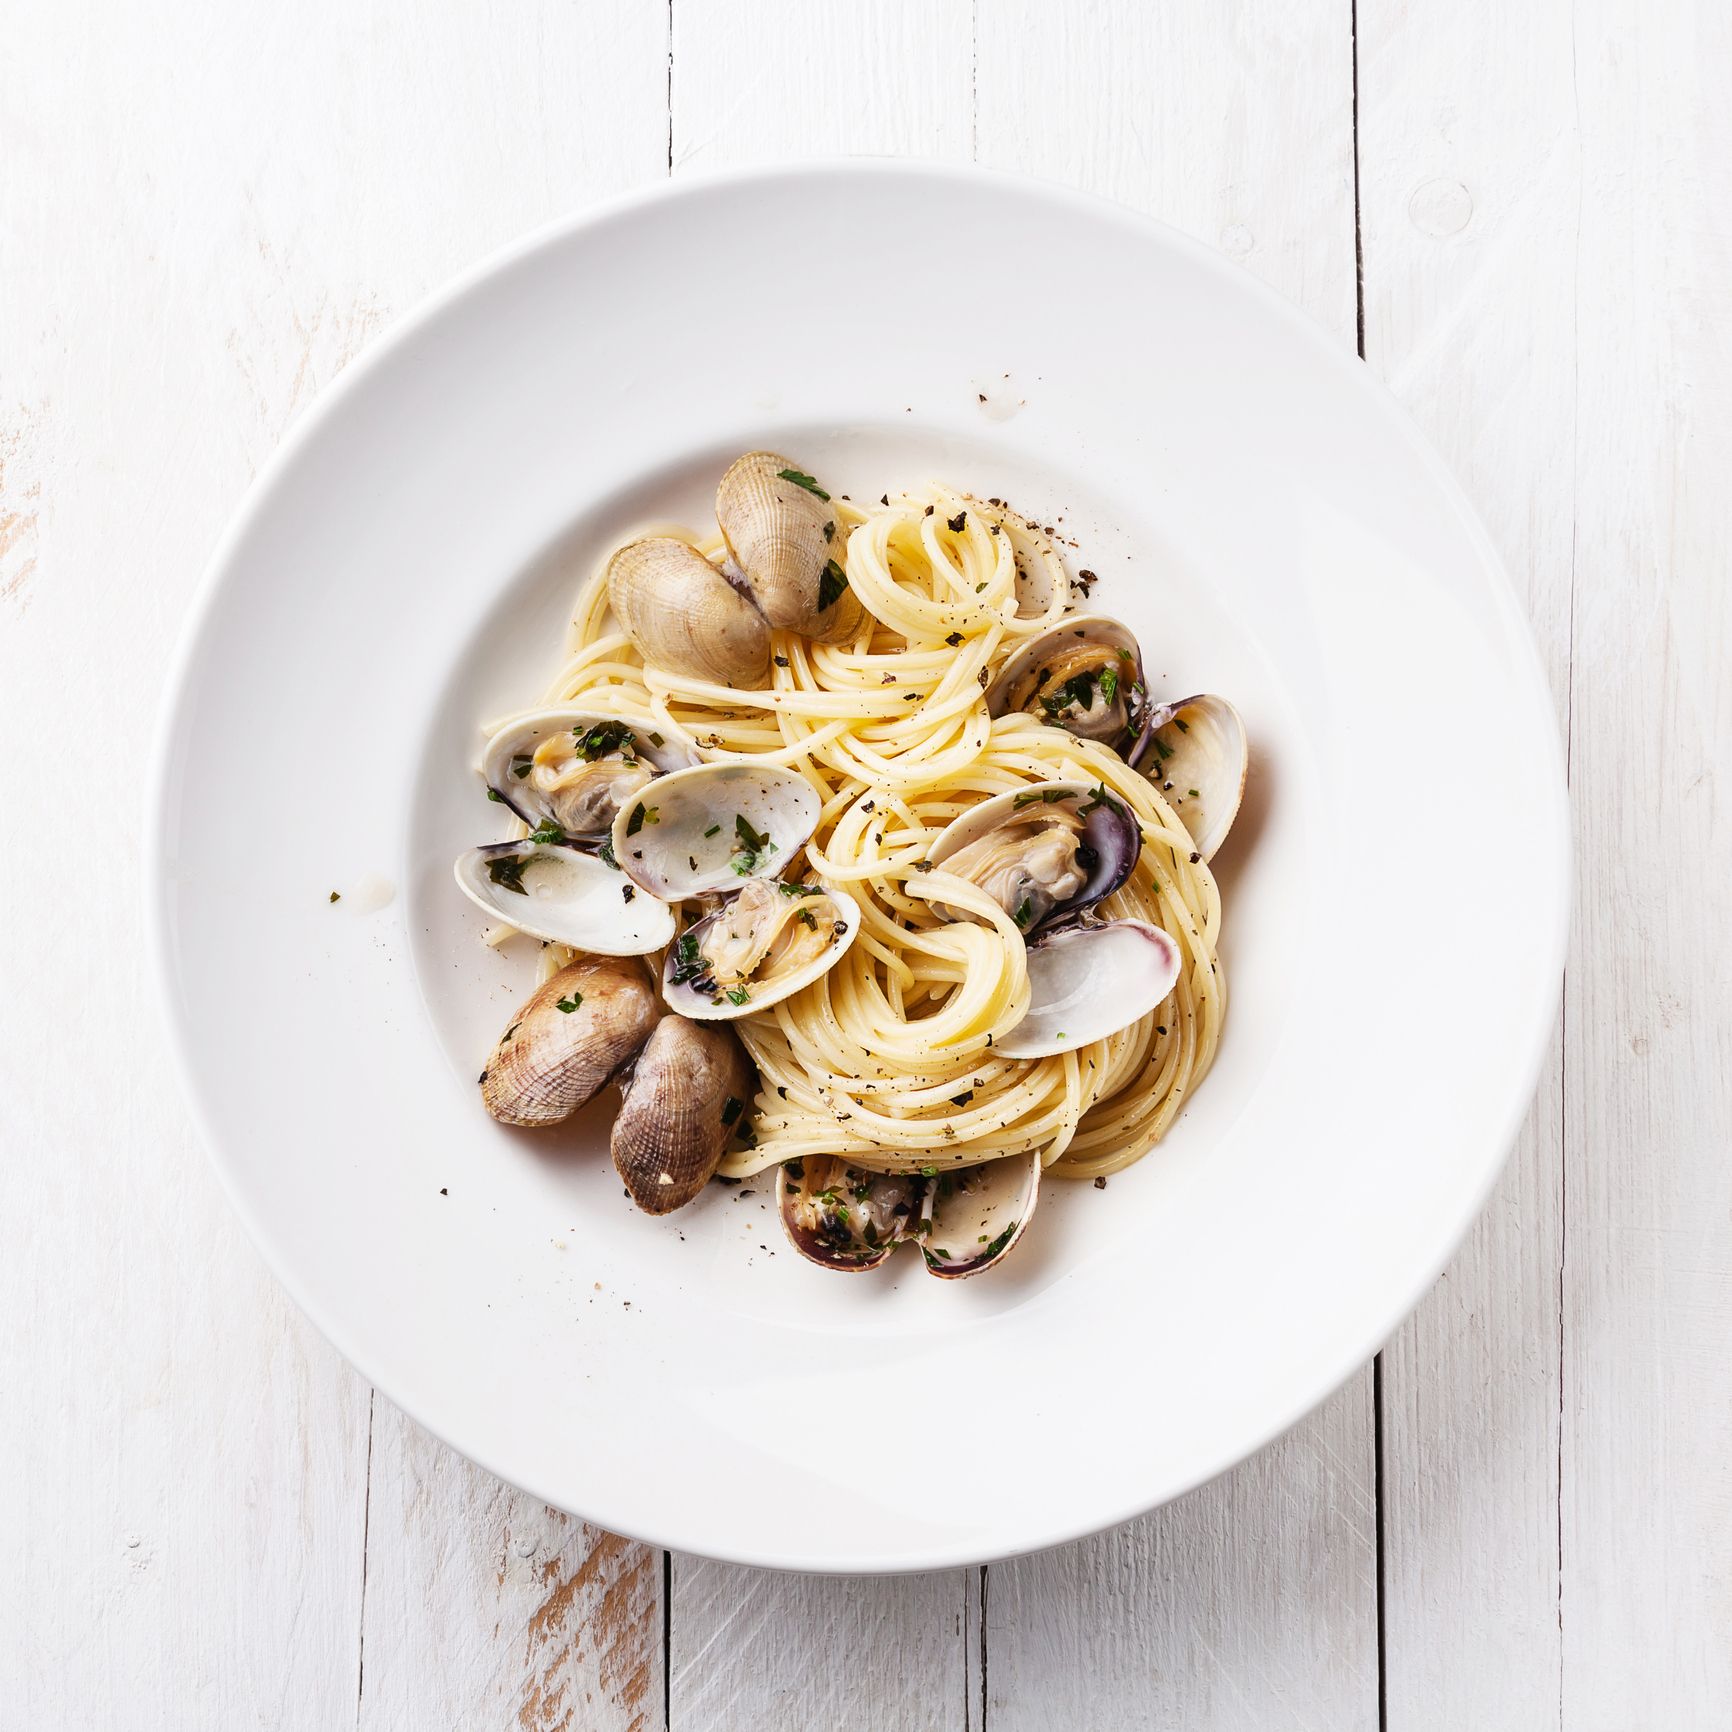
[0,0,1732,1732]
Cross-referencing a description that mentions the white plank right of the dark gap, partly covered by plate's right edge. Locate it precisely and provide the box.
[1358,0,1581,1732]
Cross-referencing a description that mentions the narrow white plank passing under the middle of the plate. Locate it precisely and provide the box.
[669,0,980,1732]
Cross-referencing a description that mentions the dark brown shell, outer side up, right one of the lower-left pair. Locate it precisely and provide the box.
[610,1017,757,1214]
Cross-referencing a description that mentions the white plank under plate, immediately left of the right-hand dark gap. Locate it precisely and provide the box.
[977,0,1377,1732]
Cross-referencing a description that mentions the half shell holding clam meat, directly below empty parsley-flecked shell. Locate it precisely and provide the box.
[662,878,861,1022]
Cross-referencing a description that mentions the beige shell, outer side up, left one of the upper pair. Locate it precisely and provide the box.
[608,535,769,686]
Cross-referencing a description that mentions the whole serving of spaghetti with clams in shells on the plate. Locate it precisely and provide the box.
[456,452,1247,1276]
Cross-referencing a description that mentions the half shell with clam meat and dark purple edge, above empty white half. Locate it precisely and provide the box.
[927,781,1143,937]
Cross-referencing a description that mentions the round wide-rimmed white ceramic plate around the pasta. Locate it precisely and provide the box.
[152,163,1567,1571]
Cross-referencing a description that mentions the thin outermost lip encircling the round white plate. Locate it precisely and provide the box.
[142,154,1574,1576]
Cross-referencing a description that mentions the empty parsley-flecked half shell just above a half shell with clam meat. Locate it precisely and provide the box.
[613,764,823,902]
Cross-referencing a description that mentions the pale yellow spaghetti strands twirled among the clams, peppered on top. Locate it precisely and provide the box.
[491,487,1226,1178]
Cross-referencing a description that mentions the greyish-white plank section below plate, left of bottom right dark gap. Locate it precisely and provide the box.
[986,1377,1377,1732]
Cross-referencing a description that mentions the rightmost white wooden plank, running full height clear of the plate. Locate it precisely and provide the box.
[1561,0,1732,1732]
